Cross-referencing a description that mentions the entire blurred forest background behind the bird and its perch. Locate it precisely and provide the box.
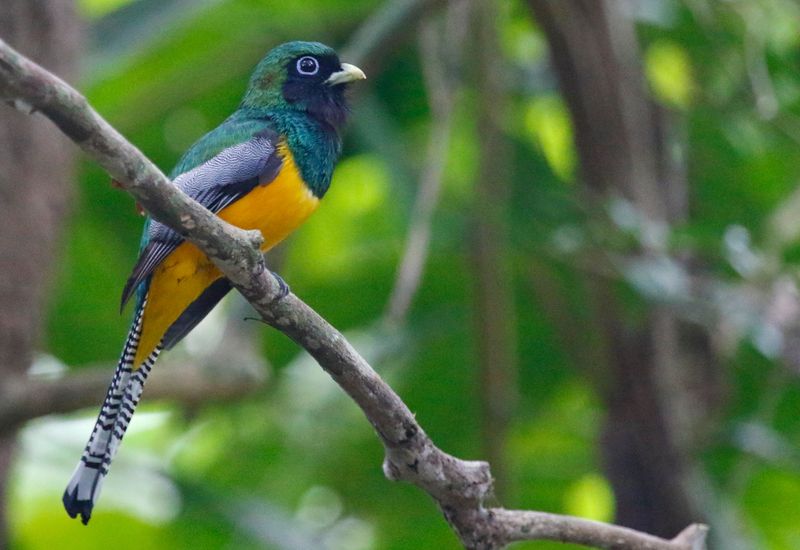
[0,0,800,550]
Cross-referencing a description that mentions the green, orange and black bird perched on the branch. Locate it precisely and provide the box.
[62,41,366,525]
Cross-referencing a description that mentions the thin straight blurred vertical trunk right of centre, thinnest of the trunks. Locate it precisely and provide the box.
[471,0,517,497]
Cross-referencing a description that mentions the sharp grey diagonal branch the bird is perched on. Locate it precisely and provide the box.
[0,33,704,550]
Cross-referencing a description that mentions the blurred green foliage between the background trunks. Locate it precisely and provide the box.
[11,0,800,550]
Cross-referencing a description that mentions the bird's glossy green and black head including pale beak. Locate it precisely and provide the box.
[242,42,366,128]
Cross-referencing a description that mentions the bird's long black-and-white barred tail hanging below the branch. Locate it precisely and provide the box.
[62,304,161,525]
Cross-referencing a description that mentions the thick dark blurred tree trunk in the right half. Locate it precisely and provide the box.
[529,0,720,537]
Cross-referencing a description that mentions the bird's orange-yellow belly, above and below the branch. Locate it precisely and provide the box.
[133,145,319,368]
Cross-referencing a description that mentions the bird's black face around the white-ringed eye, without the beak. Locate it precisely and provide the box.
[283,55,347,128]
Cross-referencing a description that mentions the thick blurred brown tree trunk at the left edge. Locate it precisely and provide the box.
[0,0,80,548]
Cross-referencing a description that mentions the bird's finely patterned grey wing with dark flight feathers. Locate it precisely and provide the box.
[120,132,282,308]
